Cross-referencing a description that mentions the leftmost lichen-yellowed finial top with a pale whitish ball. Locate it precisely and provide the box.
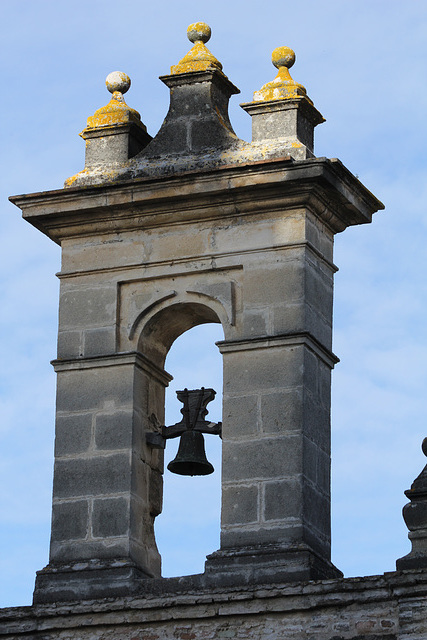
[87,71,141,129]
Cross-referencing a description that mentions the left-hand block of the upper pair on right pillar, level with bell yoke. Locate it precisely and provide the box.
[222,395,259,439]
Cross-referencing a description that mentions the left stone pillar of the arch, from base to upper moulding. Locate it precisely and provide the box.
[34,273,171,602]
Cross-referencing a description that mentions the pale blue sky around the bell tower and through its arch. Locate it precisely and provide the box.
[0,0,427,606]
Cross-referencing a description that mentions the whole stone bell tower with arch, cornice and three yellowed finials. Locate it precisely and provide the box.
[12,23,383,603]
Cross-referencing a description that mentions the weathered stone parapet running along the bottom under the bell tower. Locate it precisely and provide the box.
[0,571,427,640]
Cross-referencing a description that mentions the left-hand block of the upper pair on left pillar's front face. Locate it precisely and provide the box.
[55,413,92,457]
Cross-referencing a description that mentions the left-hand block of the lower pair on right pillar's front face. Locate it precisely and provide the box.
[221,484,259,526]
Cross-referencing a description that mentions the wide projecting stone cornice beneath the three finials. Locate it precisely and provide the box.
[10,157,384,244]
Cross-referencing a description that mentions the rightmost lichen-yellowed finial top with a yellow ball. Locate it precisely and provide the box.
[254,47,311,102]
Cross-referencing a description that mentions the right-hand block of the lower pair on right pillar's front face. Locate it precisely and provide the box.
[263,478,303,521]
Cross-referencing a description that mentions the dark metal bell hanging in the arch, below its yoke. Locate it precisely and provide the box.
[168,430,214,476]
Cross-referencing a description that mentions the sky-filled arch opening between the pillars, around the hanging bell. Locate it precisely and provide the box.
[155,323,224,577]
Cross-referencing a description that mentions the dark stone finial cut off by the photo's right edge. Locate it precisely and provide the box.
[396,438,427,570]
